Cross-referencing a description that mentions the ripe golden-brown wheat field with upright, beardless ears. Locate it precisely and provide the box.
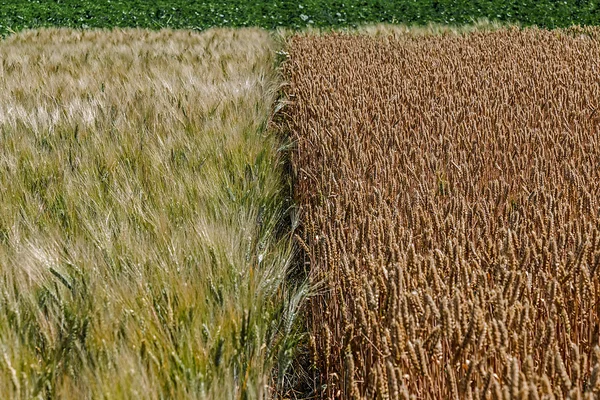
[284,28,600,399]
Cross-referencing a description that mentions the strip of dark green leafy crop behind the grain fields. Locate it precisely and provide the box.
[0,0,600,36]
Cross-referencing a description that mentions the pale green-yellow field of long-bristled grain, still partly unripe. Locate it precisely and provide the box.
[0,29,303,399]
